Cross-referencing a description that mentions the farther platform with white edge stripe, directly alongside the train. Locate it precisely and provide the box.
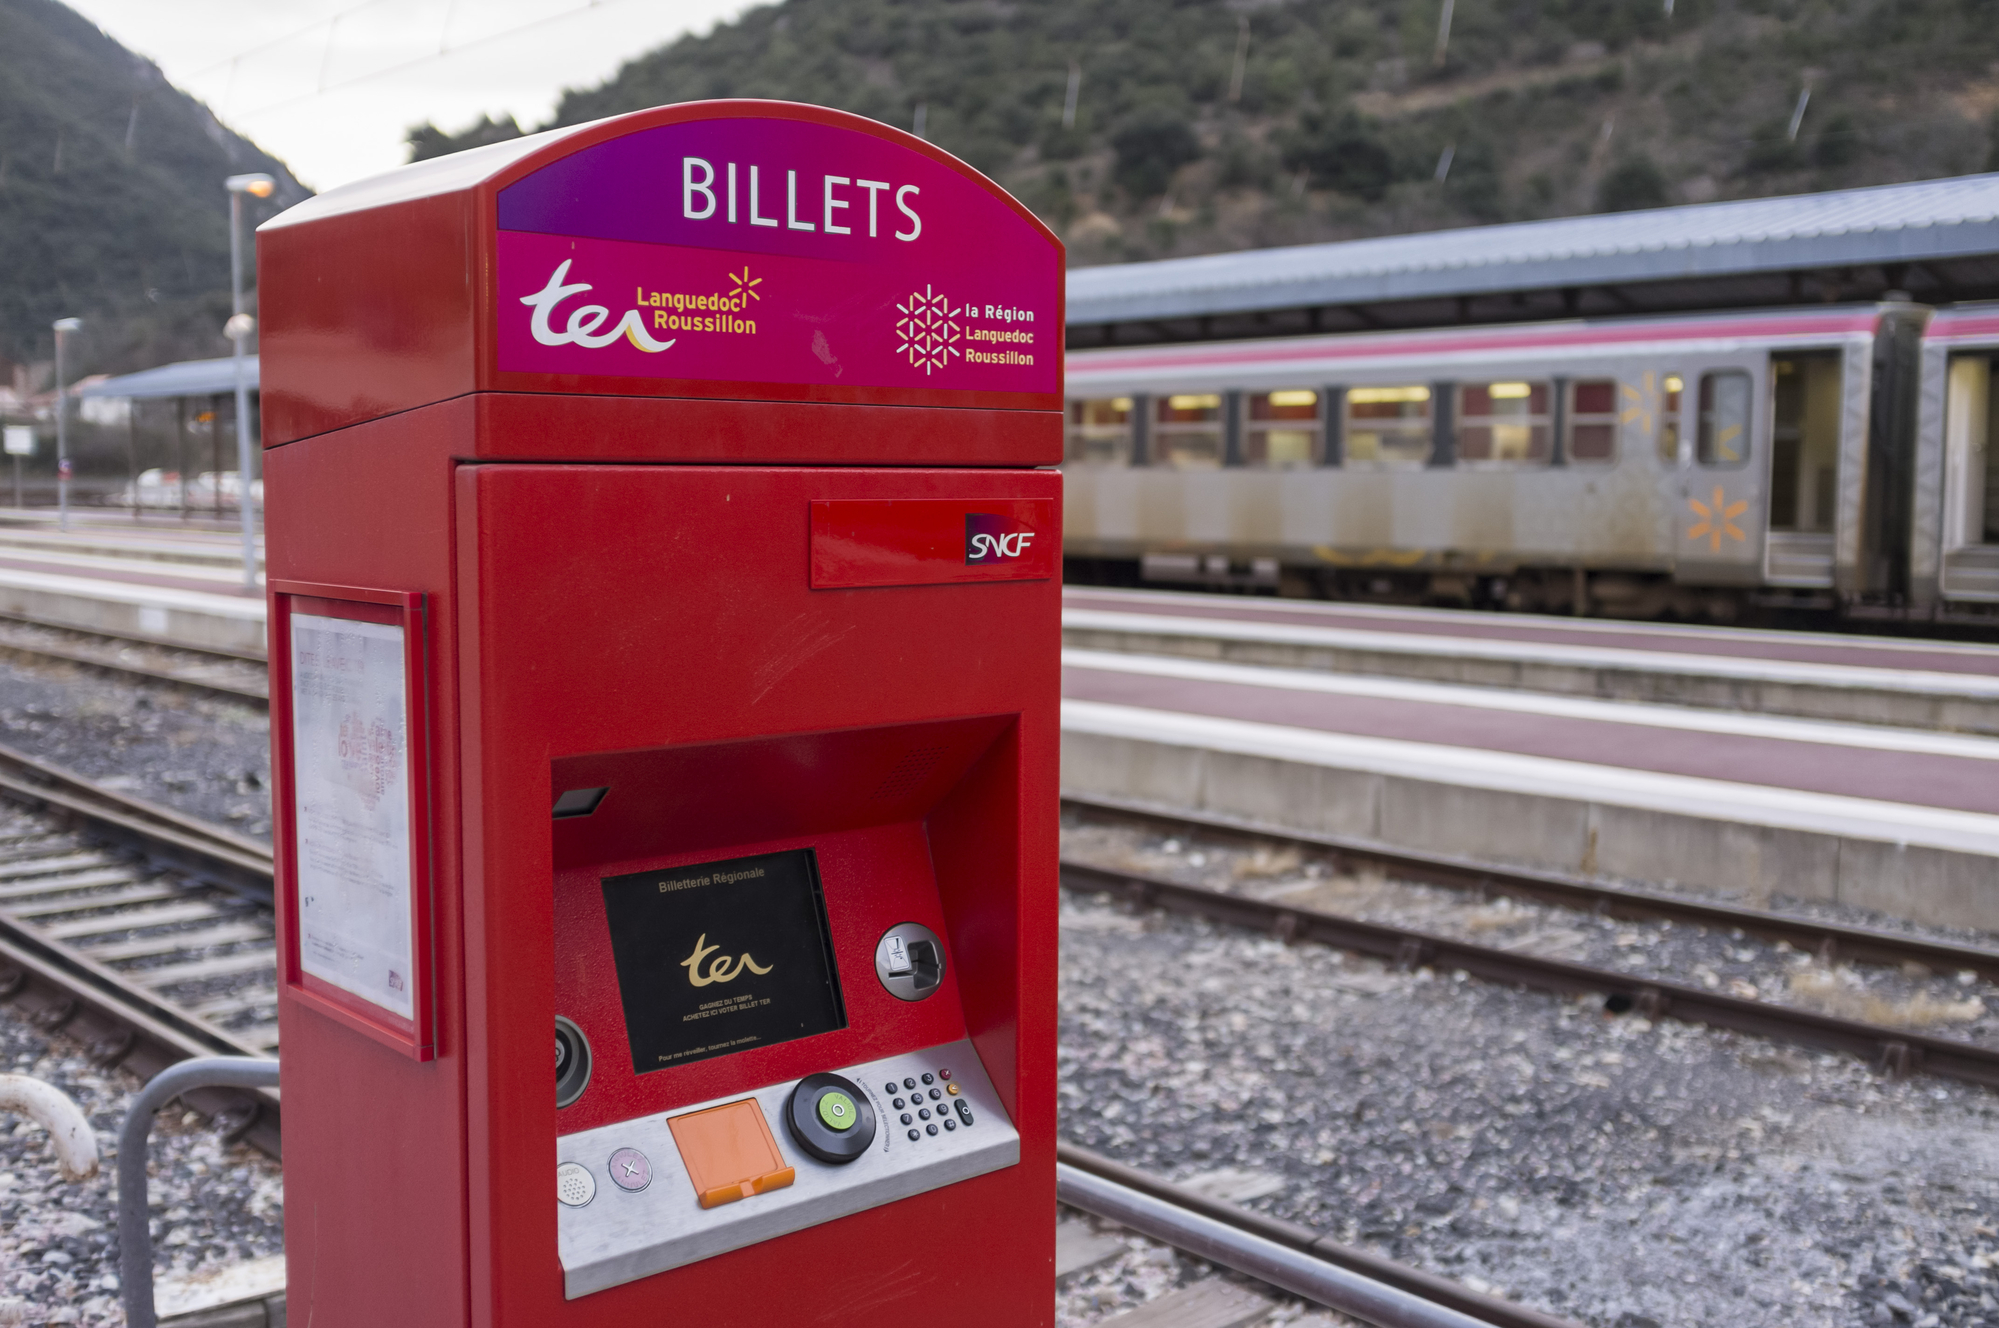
[1061,588,1999,736]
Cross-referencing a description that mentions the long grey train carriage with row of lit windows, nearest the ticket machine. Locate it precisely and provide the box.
[1067,302,1927,618]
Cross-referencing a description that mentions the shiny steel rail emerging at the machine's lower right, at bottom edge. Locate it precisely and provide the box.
[1055,1142,1577,1328]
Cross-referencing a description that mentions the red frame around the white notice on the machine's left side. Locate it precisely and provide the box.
[270,580,438,1060]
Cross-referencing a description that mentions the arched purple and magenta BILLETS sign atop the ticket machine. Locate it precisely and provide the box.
[496,116,1061,394]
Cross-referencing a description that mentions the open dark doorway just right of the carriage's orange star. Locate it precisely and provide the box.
[1763,350,1843,590]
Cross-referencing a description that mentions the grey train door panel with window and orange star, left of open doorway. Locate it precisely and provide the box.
[1675,364,1765,586]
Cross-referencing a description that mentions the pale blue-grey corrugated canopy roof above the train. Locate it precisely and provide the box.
[1067,174,1999,346]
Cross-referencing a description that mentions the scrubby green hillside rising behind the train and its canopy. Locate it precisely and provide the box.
[412,0,1999,264]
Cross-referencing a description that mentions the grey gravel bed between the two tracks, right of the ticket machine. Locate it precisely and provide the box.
[1059,896,1999,1328]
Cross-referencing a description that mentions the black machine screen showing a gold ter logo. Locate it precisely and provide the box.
[604,848,848,1074]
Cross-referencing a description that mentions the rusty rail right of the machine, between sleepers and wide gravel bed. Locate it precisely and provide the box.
[1061,862,1999,1088]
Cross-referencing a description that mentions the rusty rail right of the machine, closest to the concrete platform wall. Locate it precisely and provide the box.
[1061,794,1999,982]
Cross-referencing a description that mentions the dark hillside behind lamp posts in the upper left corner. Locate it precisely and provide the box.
[0,0,306,384]
